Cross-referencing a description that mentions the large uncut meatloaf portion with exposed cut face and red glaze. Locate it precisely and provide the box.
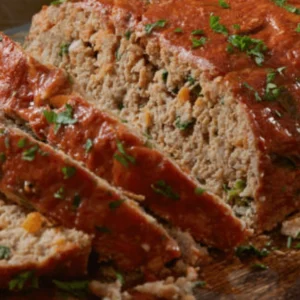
[27,0,300,231]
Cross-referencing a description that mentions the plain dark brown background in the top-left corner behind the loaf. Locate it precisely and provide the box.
[0,0,53,30]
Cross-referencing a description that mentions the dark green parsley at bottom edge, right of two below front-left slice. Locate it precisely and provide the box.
[53,280,89,298]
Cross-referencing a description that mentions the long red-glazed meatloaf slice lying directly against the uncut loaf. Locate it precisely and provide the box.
[0,32,247,248]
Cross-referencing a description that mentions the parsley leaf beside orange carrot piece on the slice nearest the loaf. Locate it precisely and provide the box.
[43,104,77,133]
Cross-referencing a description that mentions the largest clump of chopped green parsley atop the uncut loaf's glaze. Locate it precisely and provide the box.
[228,35,267,66]
